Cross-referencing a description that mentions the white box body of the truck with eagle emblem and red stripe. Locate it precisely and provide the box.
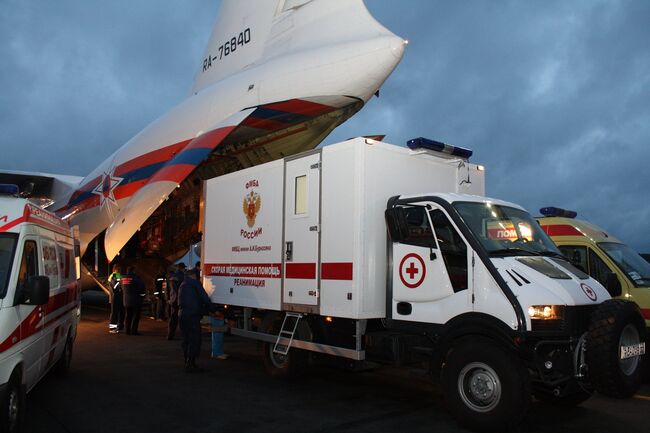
[202,138,485,319]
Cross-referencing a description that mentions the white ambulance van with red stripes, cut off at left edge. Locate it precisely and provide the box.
[0,184,80,433]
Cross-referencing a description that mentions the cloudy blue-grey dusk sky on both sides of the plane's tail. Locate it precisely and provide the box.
[0,0,650,252]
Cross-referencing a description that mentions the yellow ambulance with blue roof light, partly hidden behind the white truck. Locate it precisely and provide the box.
[537,207,650,327]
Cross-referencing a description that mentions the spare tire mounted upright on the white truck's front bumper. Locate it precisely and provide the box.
[586,299,647,398]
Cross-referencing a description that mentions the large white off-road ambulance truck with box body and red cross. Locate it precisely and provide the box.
[202,138,645,431]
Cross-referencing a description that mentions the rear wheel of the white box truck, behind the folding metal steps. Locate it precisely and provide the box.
[262,317,308,379]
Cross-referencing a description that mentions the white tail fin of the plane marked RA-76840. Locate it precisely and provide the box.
[192,0,394,93]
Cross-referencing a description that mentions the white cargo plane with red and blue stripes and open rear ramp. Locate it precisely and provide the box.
[0,0,407,274]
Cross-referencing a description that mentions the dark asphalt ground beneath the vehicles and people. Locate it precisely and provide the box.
[26,295,650,433]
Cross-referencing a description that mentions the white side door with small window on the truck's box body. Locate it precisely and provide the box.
[282,152,321,312]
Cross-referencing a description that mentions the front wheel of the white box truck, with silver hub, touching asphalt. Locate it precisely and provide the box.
[442,339,531,432]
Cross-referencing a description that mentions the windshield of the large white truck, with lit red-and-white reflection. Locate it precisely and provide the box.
[454,202,562,257]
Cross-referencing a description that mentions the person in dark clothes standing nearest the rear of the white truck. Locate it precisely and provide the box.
[178,269,212,372]
